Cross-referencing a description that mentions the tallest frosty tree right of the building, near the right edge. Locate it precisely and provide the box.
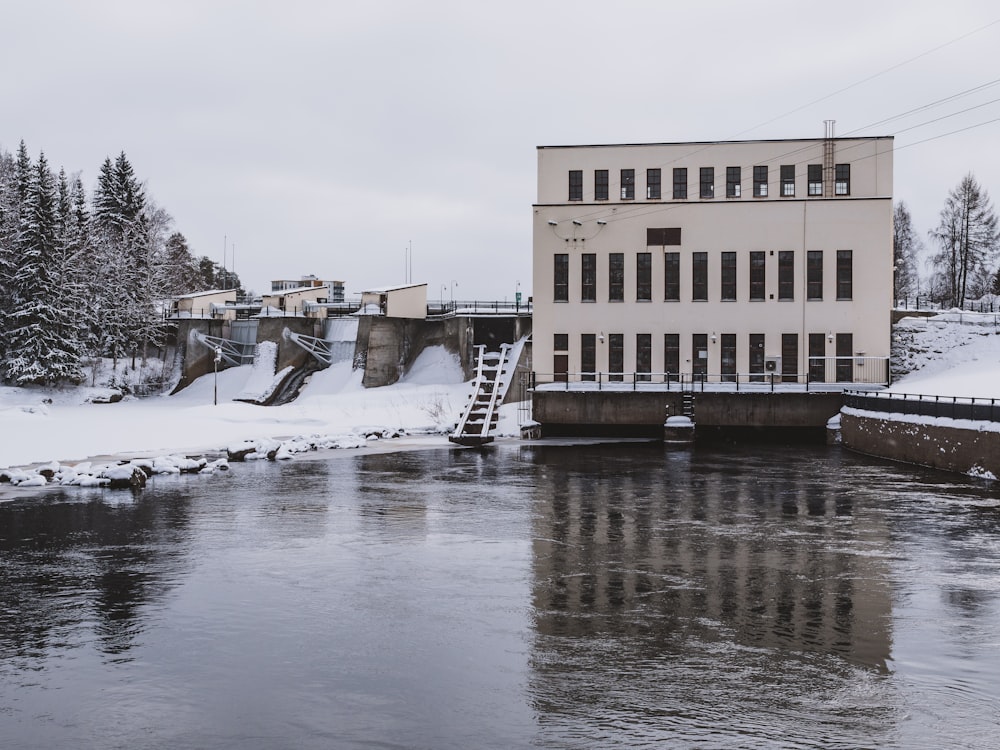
[931,173,1000,307]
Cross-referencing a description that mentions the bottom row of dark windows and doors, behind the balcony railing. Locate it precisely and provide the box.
[553,333,854,383]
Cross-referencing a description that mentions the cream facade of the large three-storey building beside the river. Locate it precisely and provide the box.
[533,137,893,390]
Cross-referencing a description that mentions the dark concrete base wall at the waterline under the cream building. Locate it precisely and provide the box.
[532,390,842,427]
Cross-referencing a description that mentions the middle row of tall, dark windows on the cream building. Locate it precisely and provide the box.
[553,250,854,302]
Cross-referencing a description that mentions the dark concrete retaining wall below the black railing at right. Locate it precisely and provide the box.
[840,414,1000,477]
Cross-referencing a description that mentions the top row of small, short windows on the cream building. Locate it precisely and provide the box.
[569,164,851,201]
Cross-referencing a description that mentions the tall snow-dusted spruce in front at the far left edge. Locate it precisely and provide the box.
[3,153,82,385]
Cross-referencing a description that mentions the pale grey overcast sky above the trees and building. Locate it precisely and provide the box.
[0,0,1000,300]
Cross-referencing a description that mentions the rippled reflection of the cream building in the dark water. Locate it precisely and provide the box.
[533,446,892,744]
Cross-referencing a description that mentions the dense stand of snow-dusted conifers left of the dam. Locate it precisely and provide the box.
[0,141,240,385]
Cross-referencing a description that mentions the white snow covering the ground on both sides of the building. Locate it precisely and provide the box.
[0,313,1000,478]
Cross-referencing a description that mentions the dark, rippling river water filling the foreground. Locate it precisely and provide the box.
[0,443,1000,750]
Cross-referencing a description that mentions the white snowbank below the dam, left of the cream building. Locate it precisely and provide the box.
[0,347,518,468]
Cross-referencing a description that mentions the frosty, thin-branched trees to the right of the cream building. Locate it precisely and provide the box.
[893,173,1000,308]
